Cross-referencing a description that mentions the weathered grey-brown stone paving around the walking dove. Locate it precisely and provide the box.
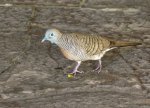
[0,0,150,108]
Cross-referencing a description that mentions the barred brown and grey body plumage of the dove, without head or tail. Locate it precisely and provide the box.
[56,33,110,61]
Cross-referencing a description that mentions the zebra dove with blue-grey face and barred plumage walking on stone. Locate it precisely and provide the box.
[41,28,142,74]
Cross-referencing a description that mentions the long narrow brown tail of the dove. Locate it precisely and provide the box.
[110,41,142,47]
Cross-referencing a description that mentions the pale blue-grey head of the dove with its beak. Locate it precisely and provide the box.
[42,29,62,44]
